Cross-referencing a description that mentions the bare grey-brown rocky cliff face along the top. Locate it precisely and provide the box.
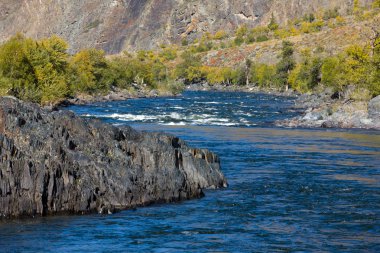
[0,0,371,53]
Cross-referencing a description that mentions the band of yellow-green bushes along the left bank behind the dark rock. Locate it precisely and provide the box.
[0,35,183,104]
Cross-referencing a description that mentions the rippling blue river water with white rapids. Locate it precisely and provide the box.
[0,92,380,252]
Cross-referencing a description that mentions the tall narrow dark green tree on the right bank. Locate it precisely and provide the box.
[276,41,295,90]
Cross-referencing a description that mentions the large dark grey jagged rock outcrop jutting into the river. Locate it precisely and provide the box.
[0,98,226,217]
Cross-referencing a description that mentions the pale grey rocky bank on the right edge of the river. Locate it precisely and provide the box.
[277,90,380,130]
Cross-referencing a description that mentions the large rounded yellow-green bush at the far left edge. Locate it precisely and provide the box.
[0,35,68,104]
